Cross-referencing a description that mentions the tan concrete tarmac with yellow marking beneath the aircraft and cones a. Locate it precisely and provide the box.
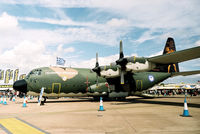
[0,96,200,134]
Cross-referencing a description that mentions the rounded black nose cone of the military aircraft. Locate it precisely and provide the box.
[13,80,27,93]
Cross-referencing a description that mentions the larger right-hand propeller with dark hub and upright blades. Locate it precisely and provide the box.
[116,41,128,84]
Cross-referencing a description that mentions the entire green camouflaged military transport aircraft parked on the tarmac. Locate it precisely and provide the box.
[13,37,200,100]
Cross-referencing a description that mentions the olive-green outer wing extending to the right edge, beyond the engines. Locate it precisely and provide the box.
[148,46,200,64]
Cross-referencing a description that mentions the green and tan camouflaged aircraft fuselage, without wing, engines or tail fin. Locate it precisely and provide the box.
[14,67,171,97]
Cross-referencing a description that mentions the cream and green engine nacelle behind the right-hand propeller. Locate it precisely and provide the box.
[126,56,156,73]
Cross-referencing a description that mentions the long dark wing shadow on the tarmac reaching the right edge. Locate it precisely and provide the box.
[112,98,200,108]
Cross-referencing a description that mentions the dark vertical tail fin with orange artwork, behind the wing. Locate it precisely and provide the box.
[161,37,179,73]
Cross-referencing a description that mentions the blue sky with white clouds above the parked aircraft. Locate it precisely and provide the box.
[0,0,200,83]
